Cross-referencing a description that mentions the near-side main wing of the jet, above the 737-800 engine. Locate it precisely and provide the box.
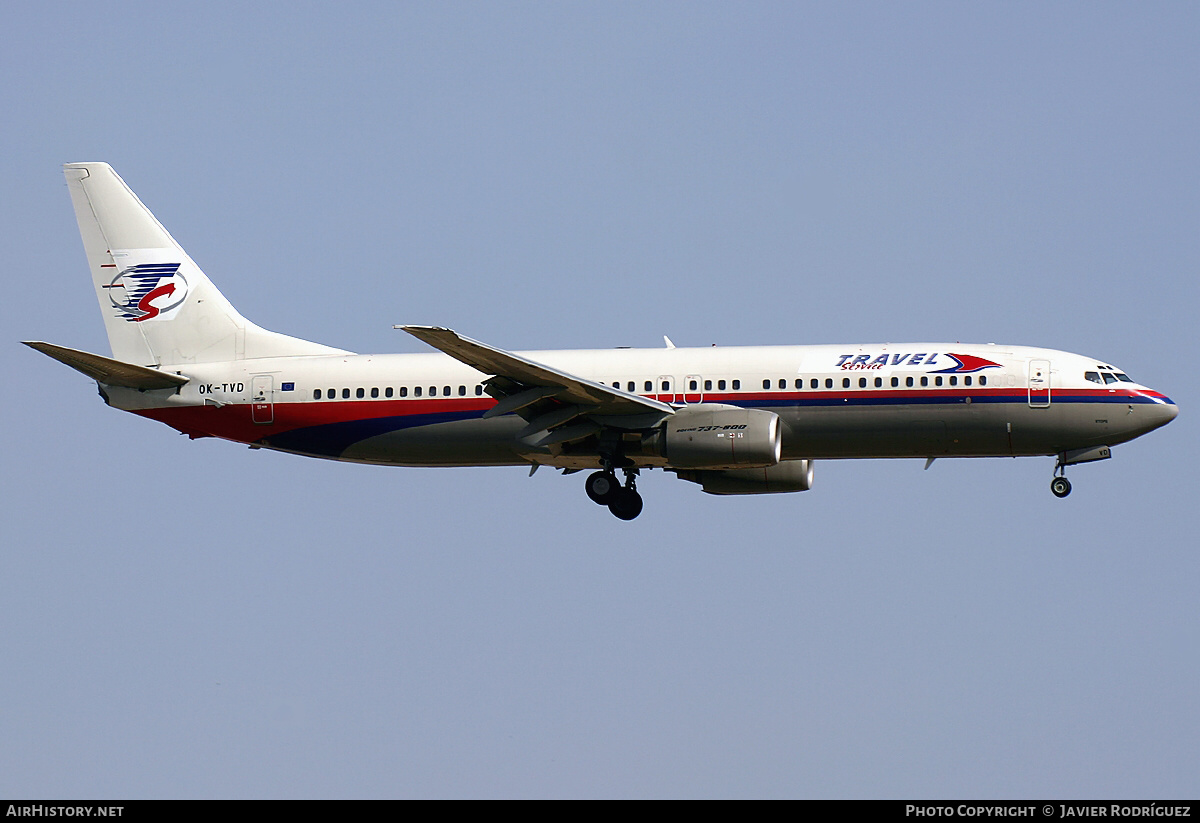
[396,326,674,446]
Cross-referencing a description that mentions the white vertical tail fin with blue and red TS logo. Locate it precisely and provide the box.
[64,163,343,366]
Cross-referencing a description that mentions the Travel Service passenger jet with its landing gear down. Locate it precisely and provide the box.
[25,163,1177,521]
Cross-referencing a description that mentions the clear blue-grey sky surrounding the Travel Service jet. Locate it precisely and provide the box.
[0,2,1200,798]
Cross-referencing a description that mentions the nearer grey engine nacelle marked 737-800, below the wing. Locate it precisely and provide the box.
[642,403,782,469]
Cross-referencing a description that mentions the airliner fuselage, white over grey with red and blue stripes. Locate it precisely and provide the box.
[108,343,1175,468]
